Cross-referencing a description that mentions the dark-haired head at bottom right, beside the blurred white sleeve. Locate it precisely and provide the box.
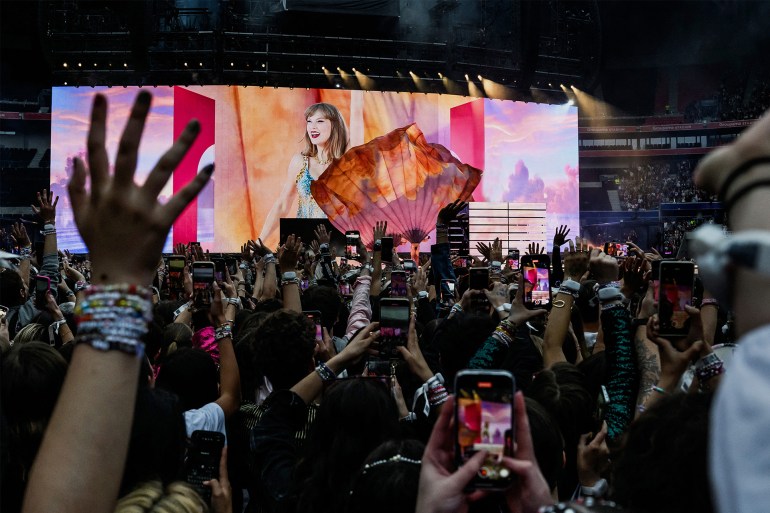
[612,393,714,513]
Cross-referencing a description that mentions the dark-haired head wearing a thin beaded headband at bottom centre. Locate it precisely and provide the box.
[345,440,425,513]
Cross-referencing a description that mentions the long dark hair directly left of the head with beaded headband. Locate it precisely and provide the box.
[294,379,399,513]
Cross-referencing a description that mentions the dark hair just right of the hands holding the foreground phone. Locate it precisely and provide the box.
[524,397,564,490]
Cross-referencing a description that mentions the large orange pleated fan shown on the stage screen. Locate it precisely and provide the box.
[310,124,482,246]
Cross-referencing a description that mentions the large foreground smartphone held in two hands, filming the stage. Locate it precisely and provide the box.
[454,370,515,490]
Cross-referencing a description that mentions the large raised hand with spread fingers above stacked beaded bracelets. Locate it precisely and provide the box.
[68,91,214,285]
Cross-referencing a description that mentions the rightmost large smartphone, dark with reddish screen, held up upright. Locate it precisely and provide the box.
[658,260,695,337]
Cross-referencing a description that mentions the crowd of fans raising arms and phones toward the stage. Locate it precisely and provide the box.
[0,92,760,513]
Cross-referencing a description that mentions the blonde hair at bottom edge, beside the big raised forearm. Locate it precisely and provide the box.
[115,481,209,513]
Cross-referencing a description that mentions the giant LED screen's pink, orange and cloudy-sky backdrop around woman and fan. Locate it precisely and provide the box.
[51,86,579,252]
